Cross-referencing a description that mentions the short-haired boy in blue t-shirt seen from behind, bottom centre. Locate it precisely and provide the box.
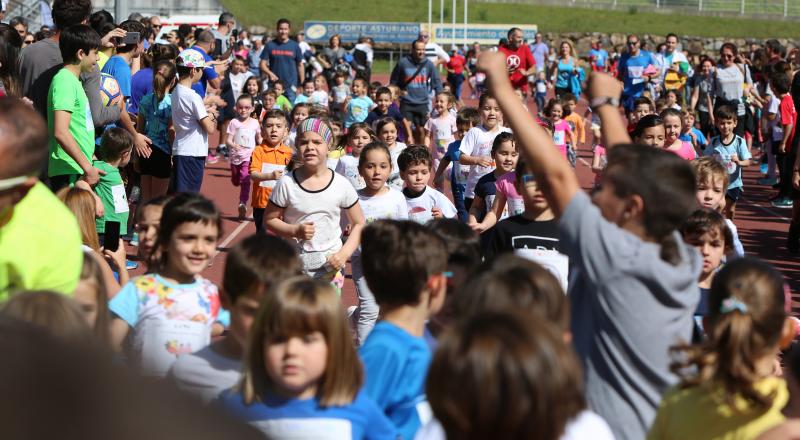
[359,220,447,439]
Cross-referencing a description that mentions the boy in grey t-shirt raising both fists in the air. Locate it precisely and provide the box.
[478,52,700,439]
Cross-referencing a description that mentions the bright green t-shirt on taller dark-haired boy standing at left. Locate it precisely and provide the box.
[47,69,94,176]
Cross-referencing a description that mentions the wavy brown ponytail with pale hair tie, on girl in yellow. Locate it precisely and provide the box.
[670,258,787,411]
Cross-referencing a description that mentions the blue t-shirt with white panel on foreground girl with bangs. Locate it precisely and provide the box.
[217,391,397,440]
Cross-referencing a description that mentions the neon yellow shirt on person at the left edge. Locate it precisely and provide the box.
[0,183,83,302]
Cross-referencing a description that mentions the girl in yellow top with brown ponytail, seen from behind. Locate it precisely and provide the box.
[647,258,795,439]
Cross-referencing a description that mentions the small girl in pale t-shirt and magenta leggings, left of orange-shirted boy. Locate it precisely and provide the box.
[225,95,262,221]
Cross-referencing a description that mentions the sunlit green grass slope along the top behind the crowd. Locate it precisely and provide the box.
[221,0,800,38]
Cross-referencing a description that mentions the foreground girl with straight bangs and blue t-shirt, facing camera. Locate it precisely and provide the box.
[220,277,398,440]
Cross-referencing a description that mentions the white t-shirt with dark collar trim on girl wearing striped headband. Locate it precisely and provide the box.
[269,170,358,255]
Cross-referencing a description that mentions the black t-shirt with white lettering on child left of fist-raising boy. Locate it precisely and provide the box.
[485,214,562,259]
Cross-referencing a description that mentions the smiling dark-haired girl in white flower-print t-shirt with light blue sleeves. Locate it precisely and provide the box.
[108,193,221,377]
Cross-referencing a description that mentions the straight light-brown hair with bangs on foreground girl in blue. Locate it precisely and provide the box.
[238,276,364,407]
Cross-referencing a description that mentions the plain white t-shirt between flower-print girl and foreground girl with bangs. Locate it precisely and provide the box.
[168,346,242,403]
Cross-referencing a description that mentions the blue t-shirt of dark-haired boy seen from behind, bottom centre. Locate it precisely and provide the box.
[359,321,431,439]
